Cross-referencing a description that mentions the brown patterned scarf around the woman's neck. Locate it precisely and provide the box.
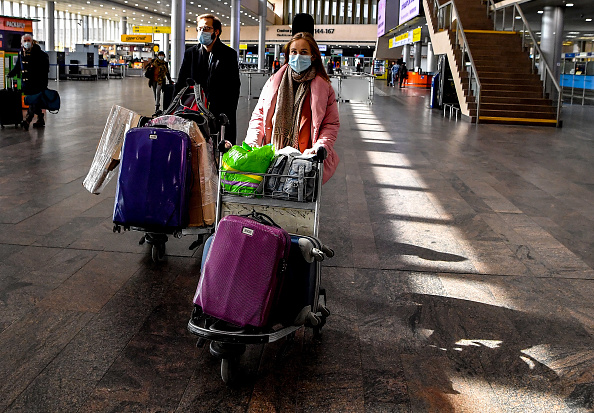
[272,66,316,150]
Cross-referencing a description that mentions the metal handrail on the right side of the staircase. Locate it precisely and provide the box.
[487,0,563,124]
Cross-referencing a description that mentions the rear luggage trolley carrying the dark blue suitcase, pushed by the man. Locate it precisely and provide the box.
[113,81,224,263]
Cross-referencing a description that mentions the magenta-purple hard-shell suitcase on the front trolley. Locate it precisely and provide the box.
[194,215,291,327]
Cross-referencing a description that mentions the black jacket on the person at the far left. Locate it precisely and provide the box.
[8,44,49,95]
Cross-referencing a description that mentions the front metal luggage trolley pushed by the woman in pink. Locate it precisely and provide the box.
[188,147,334,383]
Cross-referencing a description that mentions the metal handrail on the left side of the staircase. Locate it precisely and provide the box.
[433,0,481,123]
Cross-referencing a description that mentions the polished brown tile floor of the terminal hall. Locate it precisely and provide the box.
[0,78,594,413]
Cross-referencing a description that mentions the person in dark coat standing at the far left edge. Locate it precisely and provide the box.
[8,34,49,130]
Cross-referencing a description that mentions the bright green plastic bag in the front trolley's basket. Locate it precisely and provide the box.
[221,142,274,194]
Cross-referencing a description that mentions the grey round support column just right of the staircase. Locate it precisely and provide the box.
[540,6,564,91]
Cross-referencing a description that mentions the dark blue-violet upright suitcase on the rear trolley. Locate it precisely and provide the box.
[113,127,192,232]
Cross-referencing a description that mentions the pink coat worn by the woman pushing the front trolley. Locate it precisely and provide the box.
[245,65,340,183]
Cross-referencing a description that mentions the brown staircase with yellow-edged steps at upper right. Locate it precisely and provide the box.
[423,0,558,126]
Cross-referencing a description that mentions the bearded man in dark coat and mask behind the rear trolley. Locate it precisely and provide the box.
[175,14,240,144]
